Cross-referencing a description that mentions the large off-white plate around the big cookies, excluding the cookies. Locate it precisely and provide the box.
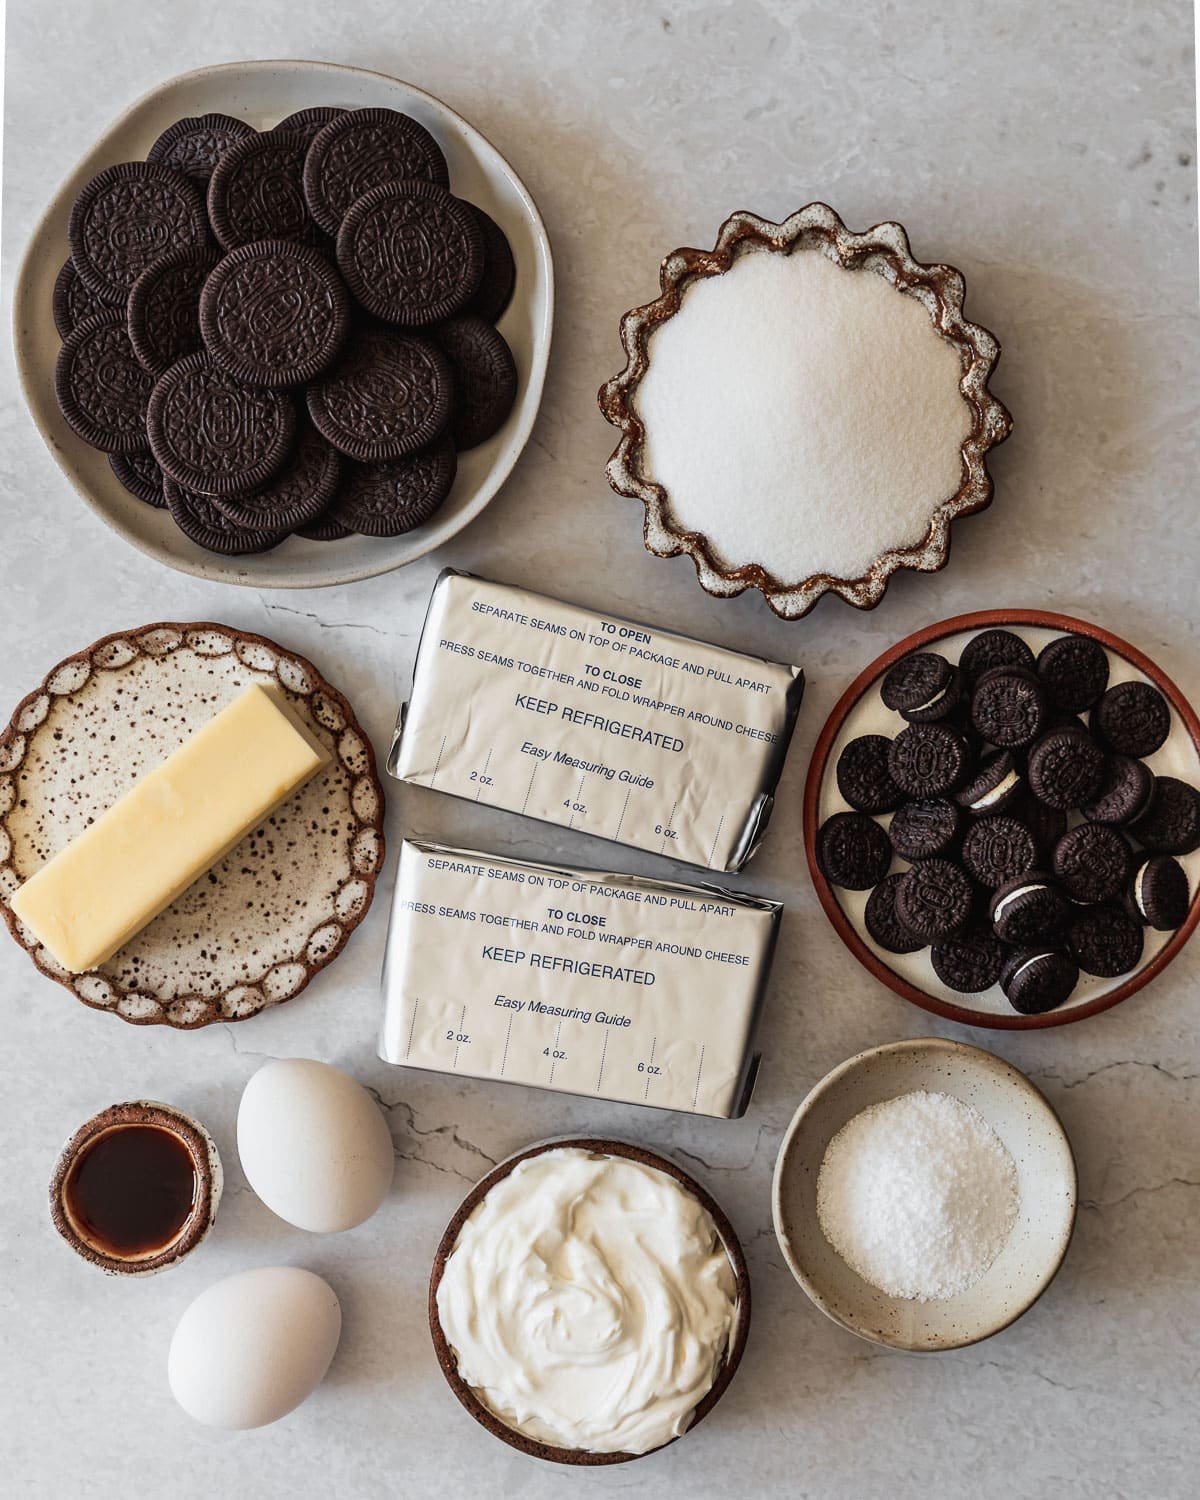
[14,62,554,588]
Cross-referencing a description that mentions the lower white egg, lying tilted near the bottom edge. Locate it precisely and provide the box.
[167,1266,342,1430]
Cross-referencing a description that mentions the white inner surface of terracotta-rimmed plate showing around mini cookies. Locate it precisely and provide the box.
[818,626,1200,1017]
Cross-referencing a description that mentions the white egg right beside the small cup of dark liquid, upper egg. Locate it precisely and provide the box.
[237,1058,396,1235]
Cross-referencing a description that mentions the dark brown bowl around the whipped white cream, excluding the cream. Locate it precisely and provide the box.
[429,1136,750,1467]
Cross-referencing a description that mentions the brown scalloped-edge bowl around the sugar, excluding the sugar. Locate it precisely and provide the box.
[599,203,1013,620]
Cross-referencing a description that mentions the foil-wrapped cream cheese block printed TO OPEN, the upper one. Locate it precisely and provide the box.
[387,570,804,870]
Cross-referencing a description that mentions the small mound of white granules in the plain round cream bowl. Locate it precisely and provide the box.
[816,1089,1019,1302]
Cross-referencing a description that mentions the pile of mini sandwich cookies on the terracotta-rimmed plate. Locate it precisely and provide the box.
[818,630,1200,1014]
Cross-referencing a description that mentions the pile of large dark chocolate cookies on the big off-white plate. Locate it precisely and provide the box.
[54,107,518,554]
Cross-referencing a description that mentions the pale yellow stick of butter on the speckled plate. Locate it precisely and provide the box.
[11,686,330,974]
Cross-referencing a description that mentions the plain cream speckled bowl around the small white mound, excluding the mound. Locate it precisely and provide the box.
[771,1037,1076,1353]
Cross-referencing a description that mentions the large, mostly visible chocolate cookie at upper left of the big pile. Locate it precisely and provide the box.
[66,162,209,308]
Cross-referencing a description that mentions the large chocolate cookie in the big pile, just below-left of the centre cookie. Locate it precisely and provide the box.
[146,354,296,498]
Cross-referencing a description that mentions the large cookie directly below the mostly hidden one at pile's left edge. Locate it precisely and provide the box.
[54,309,155,453]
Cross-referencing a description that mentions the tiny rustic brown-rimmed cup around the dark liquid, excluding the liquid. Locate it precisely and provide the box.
[50,1100,225,1277]
